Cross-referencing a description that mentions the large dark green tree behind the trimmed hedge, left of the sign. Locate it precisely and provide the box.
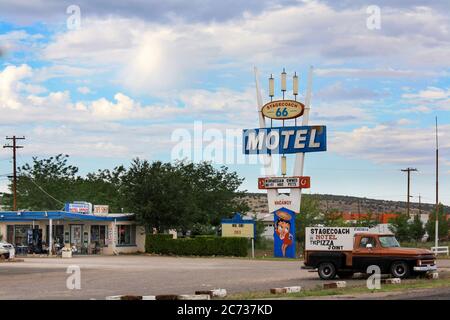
[121,159,248,232]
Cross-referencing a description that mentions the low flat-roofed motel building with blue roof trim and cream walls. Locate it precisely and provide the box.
[0,211,145,254]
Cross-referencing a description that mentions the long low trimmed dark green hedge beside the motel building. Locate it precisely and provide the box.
[145,234,248,257]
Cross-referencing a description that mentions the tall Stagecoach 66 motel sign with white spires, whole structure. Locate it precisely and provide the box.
[243,67,327,258]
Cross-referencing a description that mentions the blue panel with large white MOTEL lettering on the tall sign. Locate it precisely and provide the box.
[243,126,327,154]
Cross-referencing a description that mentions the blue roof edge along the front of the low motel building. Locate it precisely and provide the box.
[0,211,134,222]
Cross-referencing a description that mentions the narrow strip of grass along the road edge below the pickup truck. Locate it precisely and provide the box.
[227,273,450,300]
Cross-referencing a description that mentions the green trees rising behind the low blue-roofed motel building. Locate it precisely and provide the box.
[5,154,125,212]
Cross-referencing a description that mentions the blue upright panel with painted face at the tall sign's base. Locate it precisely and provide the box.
[273,208,295,258]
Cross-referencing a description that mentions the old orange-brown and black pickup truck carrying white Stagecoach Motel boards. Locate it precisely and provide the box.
[302,228,437,280]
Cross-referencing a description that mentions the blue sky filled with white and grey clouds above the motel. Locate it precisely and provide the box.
[0,0,450,204]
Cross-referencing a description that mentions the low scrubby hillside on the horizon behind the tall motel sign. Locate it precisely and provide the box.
[246,193,450,214]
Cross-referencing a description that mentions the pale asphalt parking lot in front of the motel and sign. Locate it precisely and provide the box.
[0,255,450,299]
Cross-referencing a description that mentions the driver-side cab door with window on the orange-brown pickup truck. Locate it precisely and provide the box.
[353,236,380,272]
